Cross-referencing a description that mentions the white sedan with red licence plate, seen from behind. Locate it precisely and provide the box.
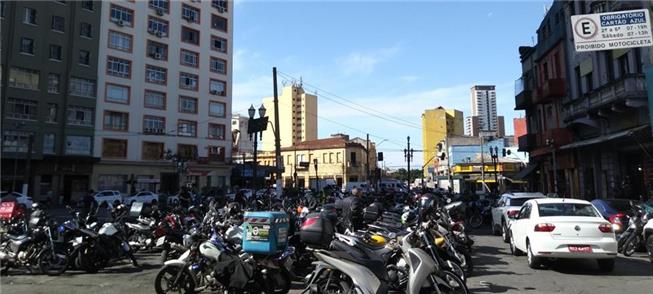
[509,198,617,272]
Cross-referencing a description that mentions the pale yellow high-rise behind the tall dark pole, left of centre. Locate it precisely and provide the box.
[259,84,317,151]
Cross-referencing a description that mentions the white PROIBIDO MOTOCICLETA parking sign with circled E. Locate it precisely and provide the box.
[571,9,653,52]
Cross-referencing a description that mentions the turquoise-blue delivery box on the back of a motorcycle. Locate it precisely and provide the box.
[243,211,288,255]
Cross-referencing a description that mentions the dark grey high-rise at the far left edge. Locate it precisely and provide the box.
[0,1,102,203]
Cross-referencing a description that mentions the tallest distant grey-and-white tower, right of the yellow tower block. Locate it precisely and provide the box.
[471,86,498,131]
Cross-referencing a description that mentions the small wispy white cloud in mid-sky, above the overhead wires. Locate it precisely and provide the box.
[336,46,399,75]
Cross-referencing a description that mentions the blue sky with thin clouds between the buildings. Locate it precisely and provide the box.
[233,0,551,168]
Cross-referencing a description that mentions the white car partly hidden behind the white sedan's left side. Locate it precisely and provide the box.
[492,192,545,243]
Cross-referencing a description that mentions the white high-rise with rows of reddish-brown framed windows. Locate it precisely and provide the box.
[92,0,233,193]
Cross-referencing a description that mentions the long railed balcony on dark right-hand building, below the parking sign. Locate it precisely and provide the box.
[563,74,648,121]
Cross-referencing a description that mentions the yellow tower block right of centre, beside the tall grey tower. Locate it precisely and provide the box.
[422,107,465,176]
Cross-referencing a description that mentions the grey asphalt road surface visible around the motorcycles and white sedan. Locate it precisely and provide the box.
[0,229,653,294]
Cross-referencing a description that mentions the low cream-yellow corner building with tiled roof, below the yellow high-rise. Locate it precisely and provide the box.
[258,134,377,188]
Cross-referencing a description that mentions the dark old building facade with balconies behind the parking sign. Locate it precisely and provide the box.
[515,1,653,199]
